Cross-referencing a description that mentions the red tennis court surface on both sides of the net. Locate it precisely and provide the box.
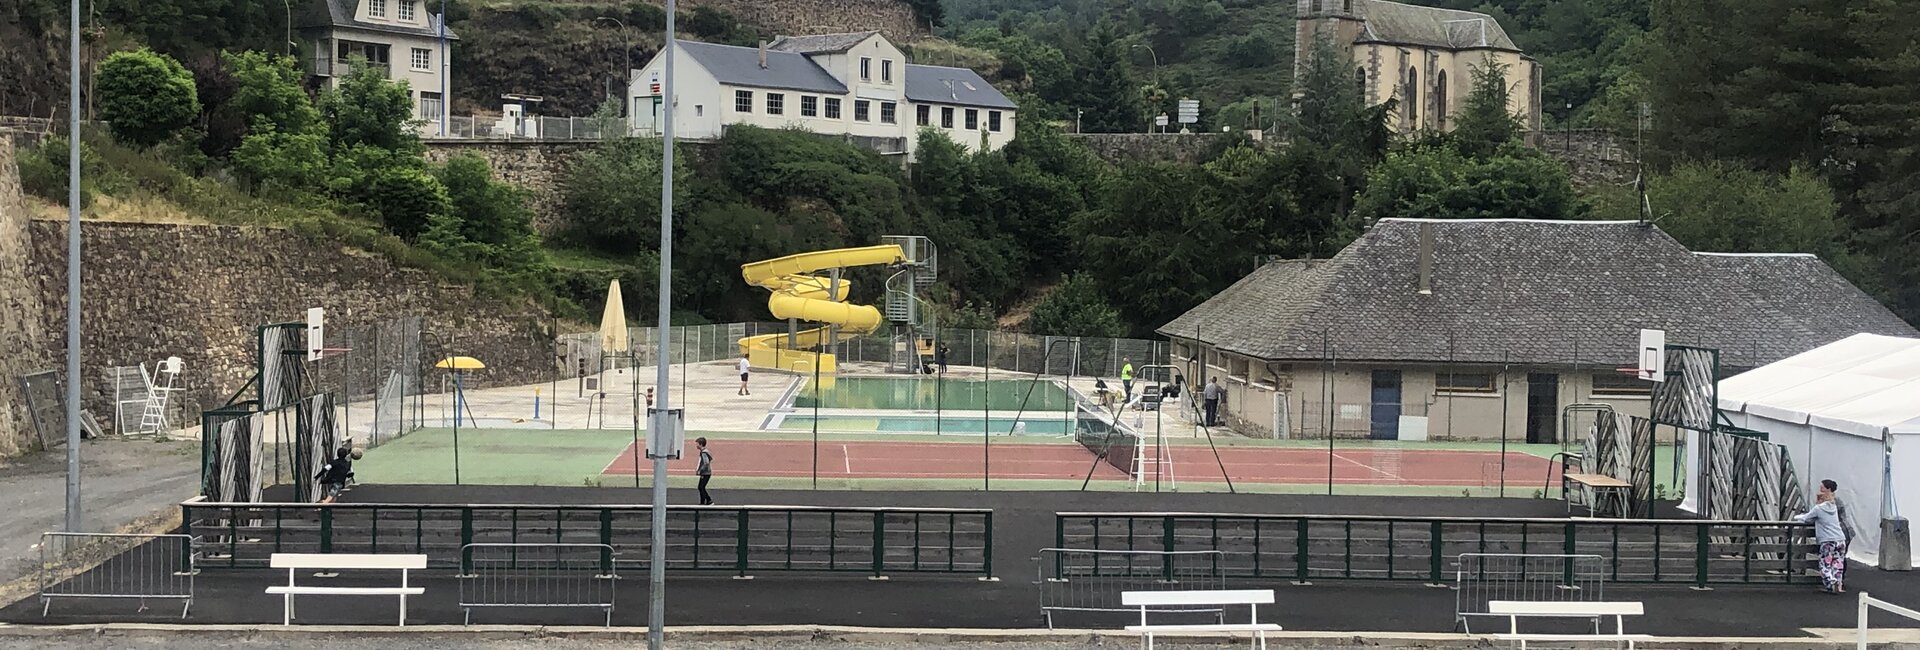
[603,441,1551,487]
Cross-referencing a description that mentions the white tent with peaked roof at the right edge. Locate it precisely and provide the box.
[1712,334,1920,564]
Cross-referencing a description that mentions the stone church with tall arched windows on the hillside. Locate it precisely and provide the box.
[1294,0,1542,132]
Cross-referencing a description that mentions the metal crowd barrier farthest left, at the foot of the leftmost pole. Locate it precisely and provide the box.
[38,533,196,619]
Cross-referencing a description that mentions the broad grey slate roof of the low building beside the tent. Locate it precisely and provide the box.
[1160,219,1920,368]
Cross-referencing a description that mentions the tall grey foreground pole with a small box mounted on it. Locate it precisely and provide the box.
[645,0,676,650]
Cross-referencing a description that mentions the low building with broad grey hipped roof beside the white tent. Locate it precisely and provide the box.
[1158,219,1920,443]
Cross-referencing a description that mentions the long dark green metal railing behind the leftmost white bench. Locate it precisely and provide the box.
[180,497,993,577]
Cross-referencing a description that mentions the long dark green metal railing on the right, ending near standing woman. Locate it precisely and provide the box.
[1054,512,1818,587]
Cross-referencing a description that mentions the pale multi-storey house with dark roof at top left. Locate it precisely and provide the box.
[298,0,459,130]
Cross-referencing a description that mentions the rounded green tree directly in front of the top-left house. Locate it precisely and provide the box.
[321,61,422,155]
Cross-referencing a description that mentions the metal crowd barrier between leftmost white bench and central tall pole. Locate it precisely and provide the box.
[461,545,620,627]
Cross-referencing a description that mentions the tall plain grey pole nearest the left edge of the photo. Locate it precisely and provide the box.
[67,0,81,533]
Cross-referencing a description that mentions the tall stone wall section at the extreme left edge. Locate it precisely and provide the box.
[0,138,55,458]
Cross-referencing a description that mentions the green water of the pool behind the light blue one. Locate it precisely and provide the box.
[789,378,1073,412]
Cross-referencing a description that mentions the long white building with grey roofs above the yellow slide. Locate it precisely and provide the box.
[628,33,1016,155]
